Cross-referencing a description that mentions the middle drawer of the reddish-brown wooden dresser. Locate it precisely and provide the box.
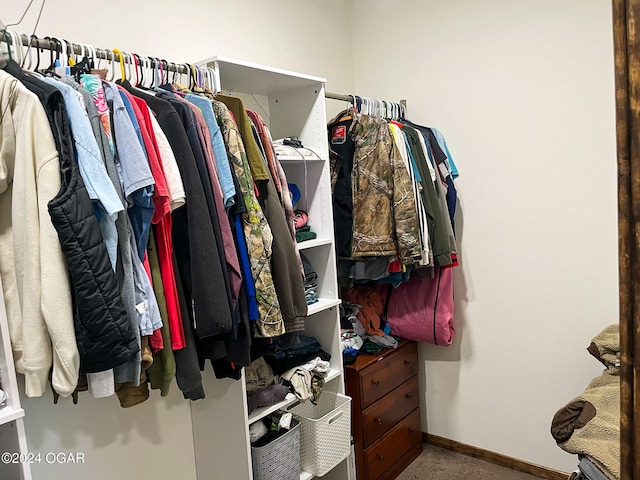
[362,375,420,448]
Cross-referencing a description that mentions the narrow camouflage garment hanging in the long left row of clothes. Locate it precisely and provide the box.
[212,100,285,338]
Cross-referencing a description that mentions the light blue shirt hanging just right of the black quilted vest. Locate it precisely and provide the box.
[43,77,124,271]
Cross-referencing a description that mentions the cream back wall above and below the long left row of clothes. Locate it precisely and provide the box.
[0,0,353,480]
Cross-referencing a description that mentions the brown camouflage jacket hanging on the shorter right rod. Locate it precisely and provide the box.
[331,109,420,264]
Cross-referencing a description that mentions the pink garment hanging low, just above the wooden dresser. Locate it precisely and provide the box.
[377,267,455,345]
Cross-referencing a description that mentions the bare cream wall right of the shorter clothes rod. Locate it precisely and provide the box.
[353,0,618,471]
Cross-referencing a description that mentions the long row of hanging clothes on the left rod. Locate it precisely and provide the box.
[0,29,307,407]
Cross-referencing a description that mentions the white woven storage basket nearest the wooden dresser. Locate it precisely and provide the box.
[287,391,351,477]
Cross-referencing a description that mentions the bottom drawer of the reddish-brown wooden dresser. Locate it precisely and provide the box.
[365,408,422,480]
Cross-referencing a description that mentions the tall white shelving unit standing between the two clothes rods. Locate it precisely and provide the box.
[191,57,349,480]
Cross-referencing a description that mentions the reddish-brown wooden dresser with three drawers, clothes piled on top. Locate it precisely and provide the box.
[345,340,422,480]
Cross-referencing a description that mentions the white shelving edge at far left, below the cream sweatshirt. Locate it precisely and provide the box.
[0,280,31,480]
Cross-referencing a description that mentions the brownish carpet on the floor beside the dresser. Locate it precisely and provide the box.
[397,445,538,480]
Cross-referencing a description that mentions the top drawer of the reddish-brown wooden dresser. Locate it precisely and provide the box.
[360,343,418,409]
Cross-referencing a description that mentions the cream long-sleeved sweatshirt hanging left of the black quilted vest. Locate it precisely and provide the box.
[0,70,80,397]
